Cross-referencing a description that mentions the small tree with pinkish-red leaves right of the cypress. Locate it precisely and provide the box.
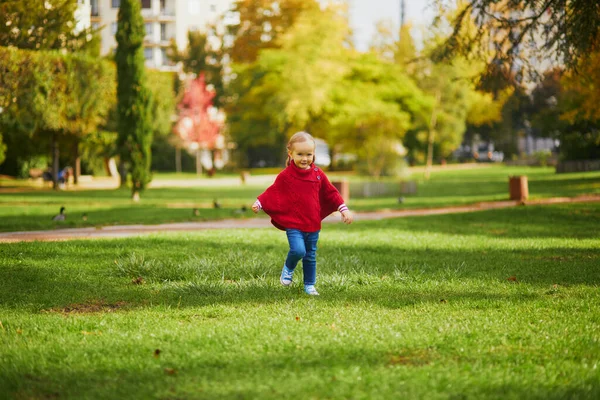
[174,74,222,150]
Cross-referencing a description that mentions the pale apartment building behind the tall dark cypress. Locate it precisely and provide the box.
[89,0,235,70]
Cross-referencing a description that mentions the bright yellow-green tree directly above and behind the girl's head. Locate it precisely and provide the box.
[227,3,348,163]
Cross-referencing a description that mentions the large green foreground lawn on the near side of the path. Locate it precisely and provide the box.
[0,202,600,399]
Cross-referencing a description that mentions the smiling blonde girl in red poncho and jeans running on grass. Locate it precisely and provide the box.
[252,132,352,296]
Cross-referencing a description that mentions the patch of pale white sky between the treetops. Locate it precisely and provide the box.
[348,0,433,51]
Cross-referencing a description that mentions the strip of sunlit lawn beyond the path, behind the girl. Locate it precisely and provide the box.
[0,166,600,232]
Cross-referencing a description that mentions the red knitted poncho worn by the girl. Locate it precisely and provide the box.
[258,162,344,232]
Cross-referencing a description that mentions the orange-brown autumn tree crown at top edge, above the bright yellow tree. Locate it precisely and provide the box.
[229,0,320,63]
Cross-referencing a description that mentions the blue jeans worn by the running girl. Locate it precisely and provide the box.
[285,229,319,285]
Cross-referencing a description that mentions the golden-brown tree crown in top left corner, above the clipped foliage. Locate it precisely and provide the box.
[0,0,99,55]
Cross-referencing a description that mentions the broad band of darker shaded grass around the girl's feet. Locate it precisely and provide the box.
[0,241,600,313]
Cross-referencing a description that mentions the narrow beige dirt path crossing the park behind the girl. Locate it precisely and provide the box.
[0,195,600,243]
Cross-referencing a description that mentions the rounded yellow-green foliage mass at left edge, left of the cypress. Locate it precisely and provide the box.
[0,47,115,173]
